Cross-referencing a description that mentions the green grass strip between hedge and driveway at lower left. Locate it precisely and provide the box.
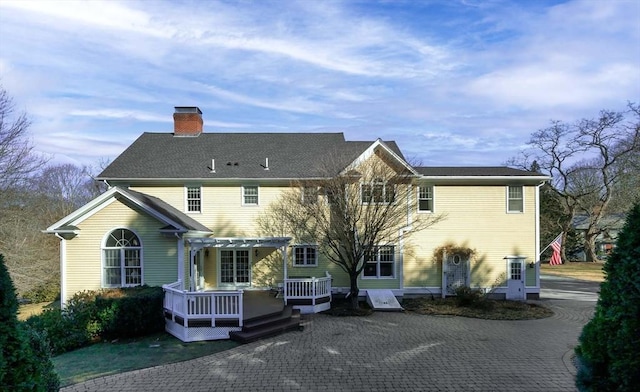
[53,333,238,387]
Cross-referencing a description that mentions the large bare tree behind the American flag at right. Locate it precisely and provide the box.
[509,103,640,261]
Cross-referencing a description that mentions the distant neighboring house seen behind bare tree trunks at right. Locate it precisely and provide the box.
[572,214,626,261]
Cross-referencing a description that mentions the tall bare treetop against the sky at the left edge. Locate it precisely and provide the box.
[0,86,45,194]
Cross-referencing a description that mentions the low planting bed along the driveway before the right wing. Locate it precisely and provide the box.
[402,297,553,320]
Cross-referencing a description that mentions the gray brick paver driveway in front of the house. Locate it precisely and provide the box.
[64,280,598,392]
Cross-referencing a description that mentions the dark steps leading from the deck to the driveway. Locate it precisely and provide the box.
[229,306,303,343]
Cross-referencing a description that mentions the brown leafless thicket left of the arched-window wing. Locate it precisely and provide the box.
[0,164,104,296]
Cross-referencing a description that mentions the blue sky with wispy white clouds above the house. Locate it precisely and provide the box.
[0,0,640,166]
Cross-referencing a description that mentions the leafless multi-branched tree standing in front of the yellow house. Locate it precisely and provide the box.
[258,157,444,309]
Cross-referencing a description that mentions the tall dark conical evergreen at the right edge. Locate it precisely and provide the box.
[576,203,640,392]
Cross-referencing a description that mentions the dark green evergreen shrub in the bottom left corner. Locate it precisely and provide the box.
[0,255,59,391]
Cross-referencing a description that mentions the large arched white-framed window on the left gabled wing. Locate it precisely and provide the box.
[102,229,142,287]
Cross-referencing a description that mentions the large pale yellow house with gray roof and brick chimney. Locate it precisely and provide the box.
[46,107,548,340]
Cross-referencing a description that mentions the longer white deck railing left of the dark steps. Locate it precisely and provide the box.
[162,281,242,327]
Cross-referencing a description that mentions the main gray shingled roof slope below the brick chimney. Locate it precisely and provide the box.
[98,133,402,180]
